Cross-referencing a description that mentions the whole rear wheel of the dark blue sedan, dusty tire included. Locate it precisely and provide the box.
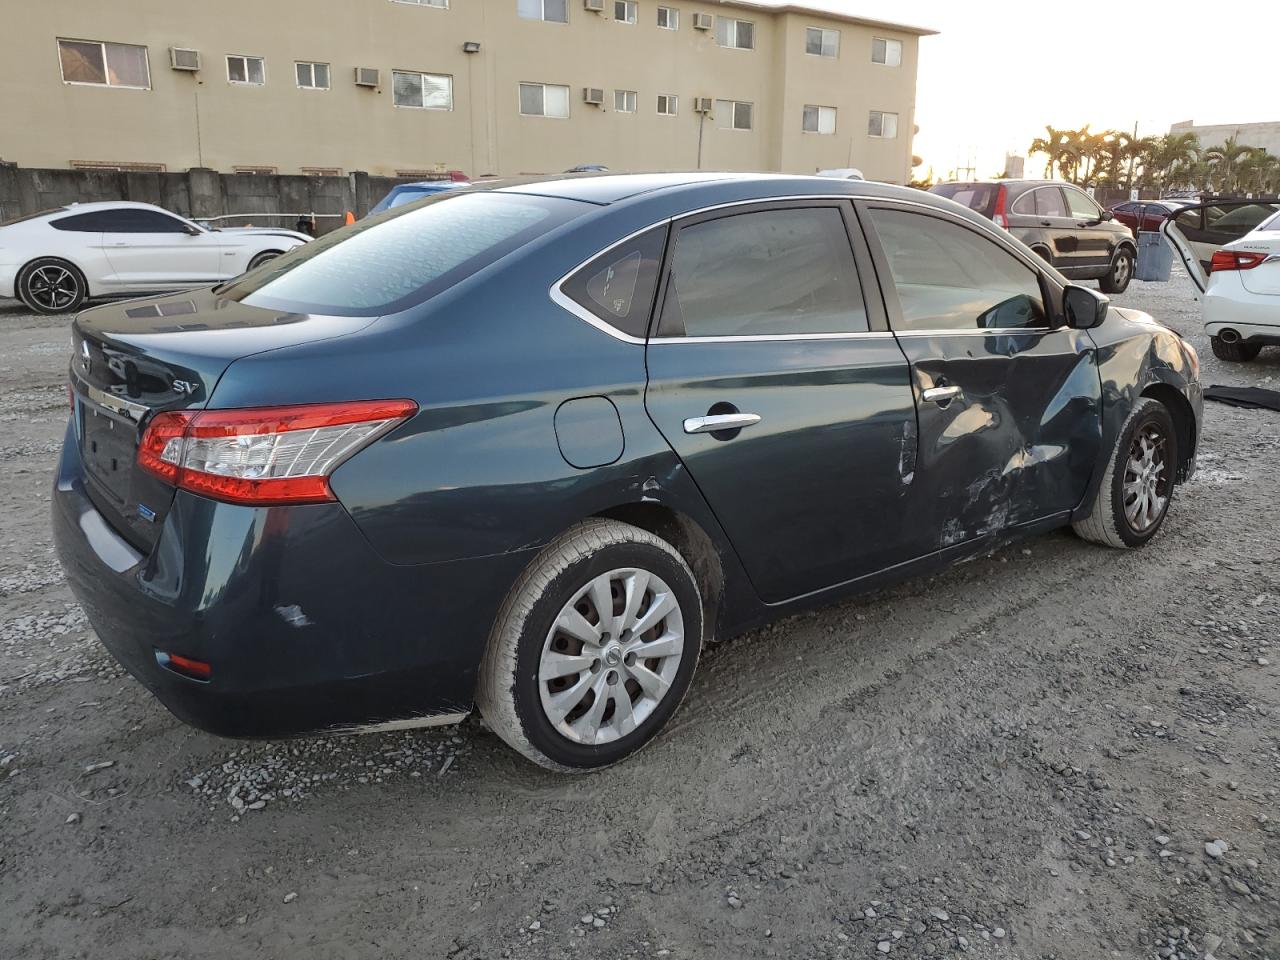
[476,520,703,773]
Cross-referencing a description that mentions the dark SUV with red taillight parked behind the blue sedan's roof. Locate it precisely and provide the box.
[929,180,1138,293]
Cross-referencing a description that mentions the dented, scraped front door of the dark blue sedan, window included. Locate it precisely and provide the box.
[860,201,1101,553]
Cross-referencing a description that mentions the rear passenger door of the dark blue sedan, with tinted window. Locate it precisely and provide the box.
[645,200,915,603]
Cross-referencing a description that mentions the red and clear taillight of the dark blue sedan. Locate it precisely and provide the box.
[138,399,417,506]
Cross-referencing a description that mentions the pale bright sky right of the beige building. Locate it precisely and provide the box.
[765,0,1280,178]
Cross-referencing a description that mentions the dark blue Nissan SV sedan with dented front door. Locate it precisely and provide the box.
[52,173,1202,771]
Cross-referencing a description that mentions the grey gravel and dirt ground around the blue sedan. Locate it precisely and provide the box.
[0,276,1280,960]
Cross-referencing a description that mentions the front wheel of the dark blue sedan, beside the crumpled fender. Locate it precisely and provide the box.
[1071,397,1178,549]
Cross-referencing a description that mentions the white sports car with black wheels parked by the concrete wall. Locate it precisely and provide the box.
[0,201,311,314]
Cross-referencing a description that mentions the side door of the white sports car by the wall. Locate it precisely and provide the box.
[102,207,221,291]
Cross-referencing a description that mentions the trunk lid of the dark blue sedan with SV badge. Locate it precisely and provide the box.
[70,291,375,552]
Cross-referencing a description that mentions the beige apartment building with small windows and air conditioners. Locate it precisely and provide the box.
[0,0,931,183]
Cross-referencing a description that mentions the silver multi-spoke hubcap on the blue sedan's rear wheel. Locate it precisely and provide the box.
[538,567,685,745]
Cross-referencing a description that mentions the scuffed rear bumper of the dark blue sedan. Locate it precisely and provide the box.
[52,419,531,737]
